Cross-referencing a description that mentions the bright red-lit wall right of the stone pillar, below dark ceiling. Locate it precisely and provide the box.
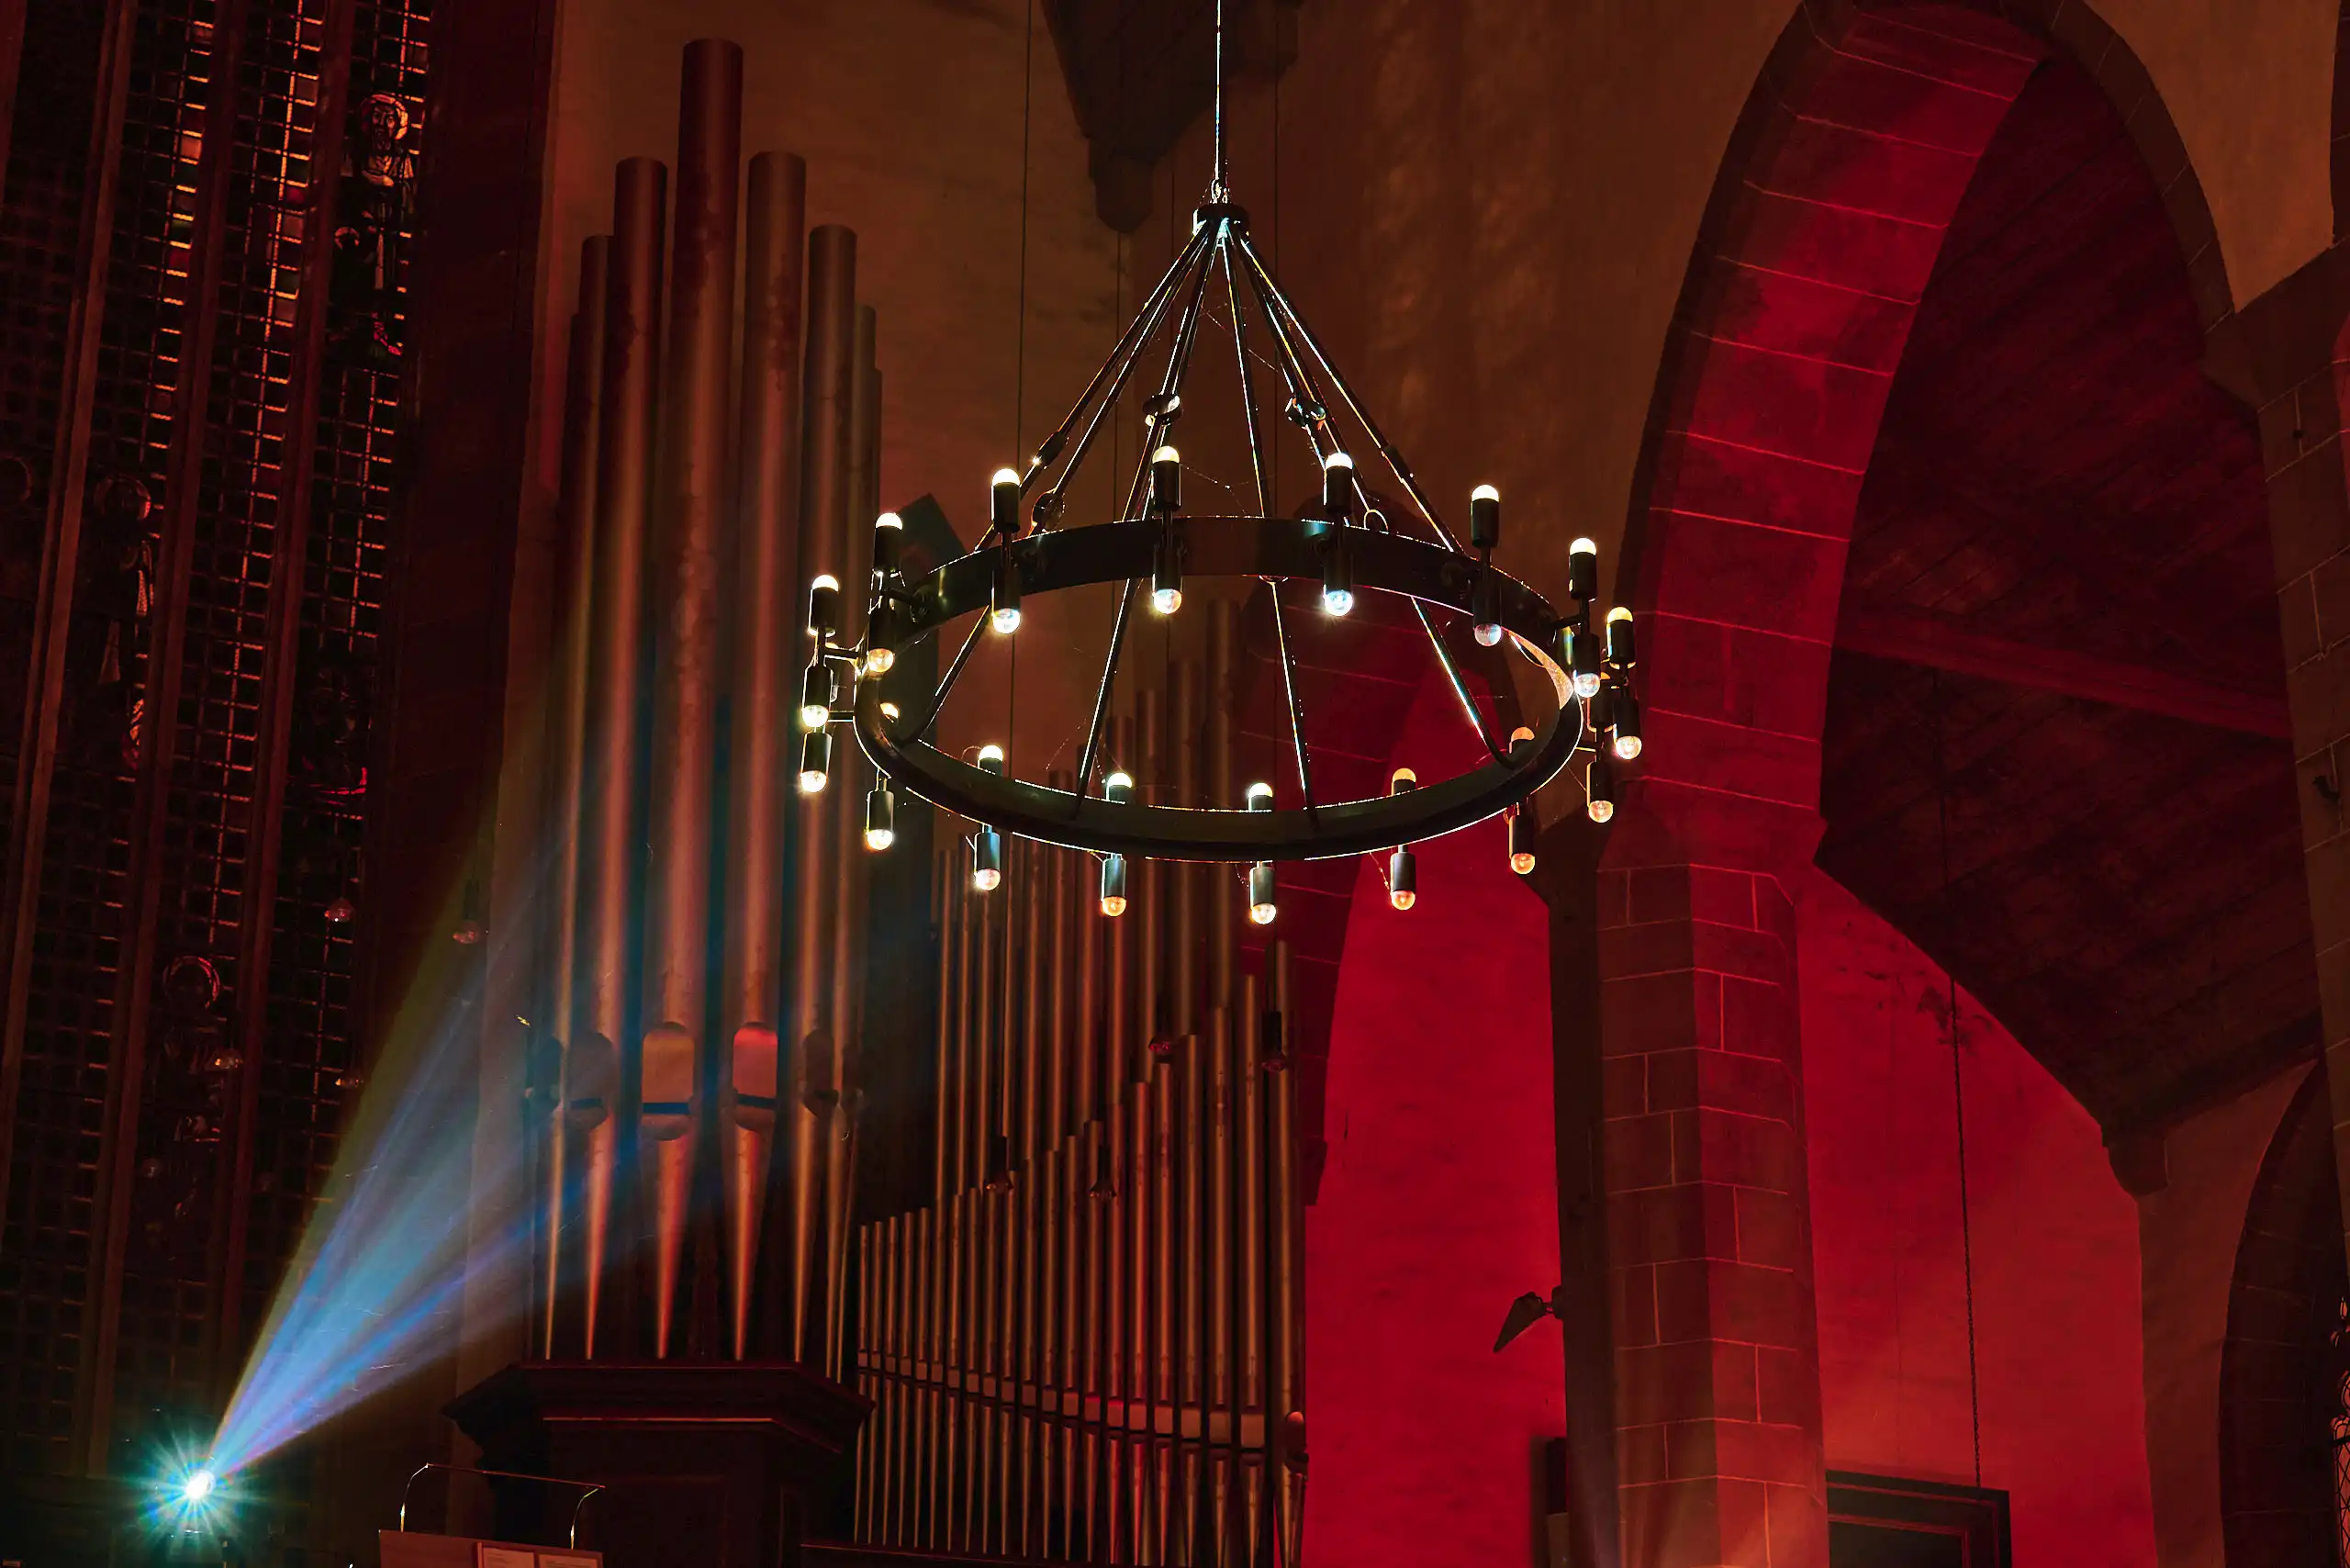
[1797,872,2155,1568]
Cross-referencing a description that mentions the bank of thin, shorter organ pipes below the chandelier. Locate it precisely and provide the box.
[853,648,1304,1568]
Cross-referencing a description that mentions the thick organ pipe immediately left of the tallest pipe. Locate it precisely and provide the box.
[564,158,667,1359]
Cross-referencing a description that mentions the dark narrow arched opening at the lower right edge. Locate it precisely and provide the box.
[2219,1072,2350,1568]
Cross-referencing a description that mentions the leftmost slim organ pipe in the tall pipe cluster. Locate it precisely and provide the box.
[538,235,611,1359]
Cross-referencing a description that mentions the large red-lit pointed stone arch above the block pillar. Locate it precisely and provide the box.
[1624,0,2232,846]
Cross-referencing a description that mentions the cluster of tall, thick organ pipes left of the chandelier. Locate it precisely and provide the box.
[533,40,878,1372]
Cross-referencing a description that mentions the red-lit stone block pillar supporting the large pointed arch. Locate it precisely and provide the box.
[1598,790,1829,1568]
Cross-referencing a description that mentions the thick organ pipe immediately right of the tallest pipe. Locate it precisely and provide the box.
[719,152,809,1359]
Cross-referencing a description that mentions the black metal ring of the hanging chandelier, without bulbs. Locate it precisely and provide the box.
[856,517,1583,863]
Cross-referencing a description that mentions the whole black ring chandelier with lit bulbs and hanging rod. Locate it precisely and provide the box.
[801,0,1640,902]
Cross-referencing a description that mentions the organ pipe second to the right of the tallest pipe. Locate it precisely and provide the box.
[785,223,857,1359]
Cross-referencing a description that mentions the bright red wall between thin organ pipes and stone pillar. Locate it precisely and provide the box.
[1306,682,1565,1568]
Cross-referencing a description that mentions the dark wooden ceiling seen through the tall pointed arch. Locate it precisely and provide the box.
[1818,63,2317,1143]
